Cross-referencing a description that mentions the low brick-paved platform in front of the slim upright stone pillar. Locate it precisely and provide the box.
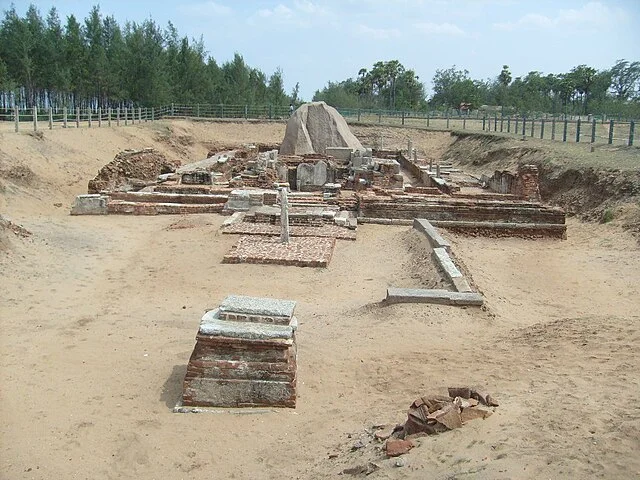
[222,235,336,267]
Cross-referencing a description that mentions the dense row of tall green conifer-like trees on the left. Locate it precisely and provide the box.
[0,5,299,109]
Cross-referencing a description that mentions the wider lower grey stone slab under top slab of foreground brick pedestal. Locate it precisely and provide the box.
[198,308,298,343]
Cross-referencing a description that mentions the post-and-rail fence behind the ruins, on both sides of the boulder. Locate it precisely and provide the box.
[0,104,635,145]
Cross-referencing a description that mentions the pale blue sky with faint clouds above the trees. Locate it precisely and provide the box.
[5,0,640,100]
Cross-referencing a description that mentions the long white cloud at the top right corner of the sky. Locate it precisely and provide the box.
[493,2,626,31]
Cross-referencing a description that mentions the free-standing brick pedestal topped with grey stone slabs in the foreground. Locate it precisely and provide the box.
[174,295,298,413]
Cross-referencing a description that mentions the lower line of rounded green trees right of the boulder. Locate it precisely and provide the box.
[314,60,640,118]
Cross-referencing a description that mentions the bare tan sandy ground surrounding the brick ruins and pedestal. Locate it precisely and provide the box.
[0,122,640,479]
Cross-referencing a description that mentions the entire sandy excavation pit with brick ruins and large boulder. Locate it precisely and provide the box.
[0,102,640,479]
